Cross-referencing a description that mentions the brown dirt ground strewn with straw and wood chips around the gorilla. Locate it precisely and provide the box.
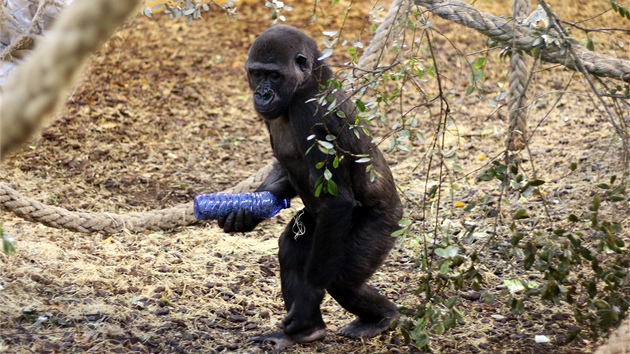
[0,0,630,353]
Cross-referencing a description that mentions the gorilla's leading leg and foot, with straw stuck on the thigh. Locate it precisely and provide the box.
[249,212,326,350]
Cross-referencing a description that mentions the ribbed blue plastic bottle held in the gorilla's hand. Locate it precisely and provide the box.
[194,192,291,220]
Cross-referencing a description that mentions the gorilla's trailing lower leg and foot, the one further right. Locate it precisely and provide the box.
[327,283,398,338]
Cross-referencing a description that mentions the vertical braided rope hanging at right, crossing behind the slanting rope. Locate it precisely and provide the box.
[508,0,530,150]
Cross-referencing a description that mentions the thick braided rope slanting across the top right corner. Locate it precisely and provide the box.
[414,0,630,82]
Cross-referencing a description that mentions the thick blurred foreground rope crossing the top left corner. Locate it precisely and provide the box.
[0,0,138,158]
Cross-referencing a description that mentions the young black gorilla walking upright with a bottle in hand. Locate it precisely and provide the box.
[219,25,402,349]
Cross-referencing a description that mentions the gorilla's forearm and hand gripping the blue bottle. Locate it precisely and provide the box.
[217,161,297,232]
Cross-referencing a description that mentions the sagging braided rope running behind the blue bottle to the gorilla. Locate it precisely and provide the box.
[0,160,275,234]
